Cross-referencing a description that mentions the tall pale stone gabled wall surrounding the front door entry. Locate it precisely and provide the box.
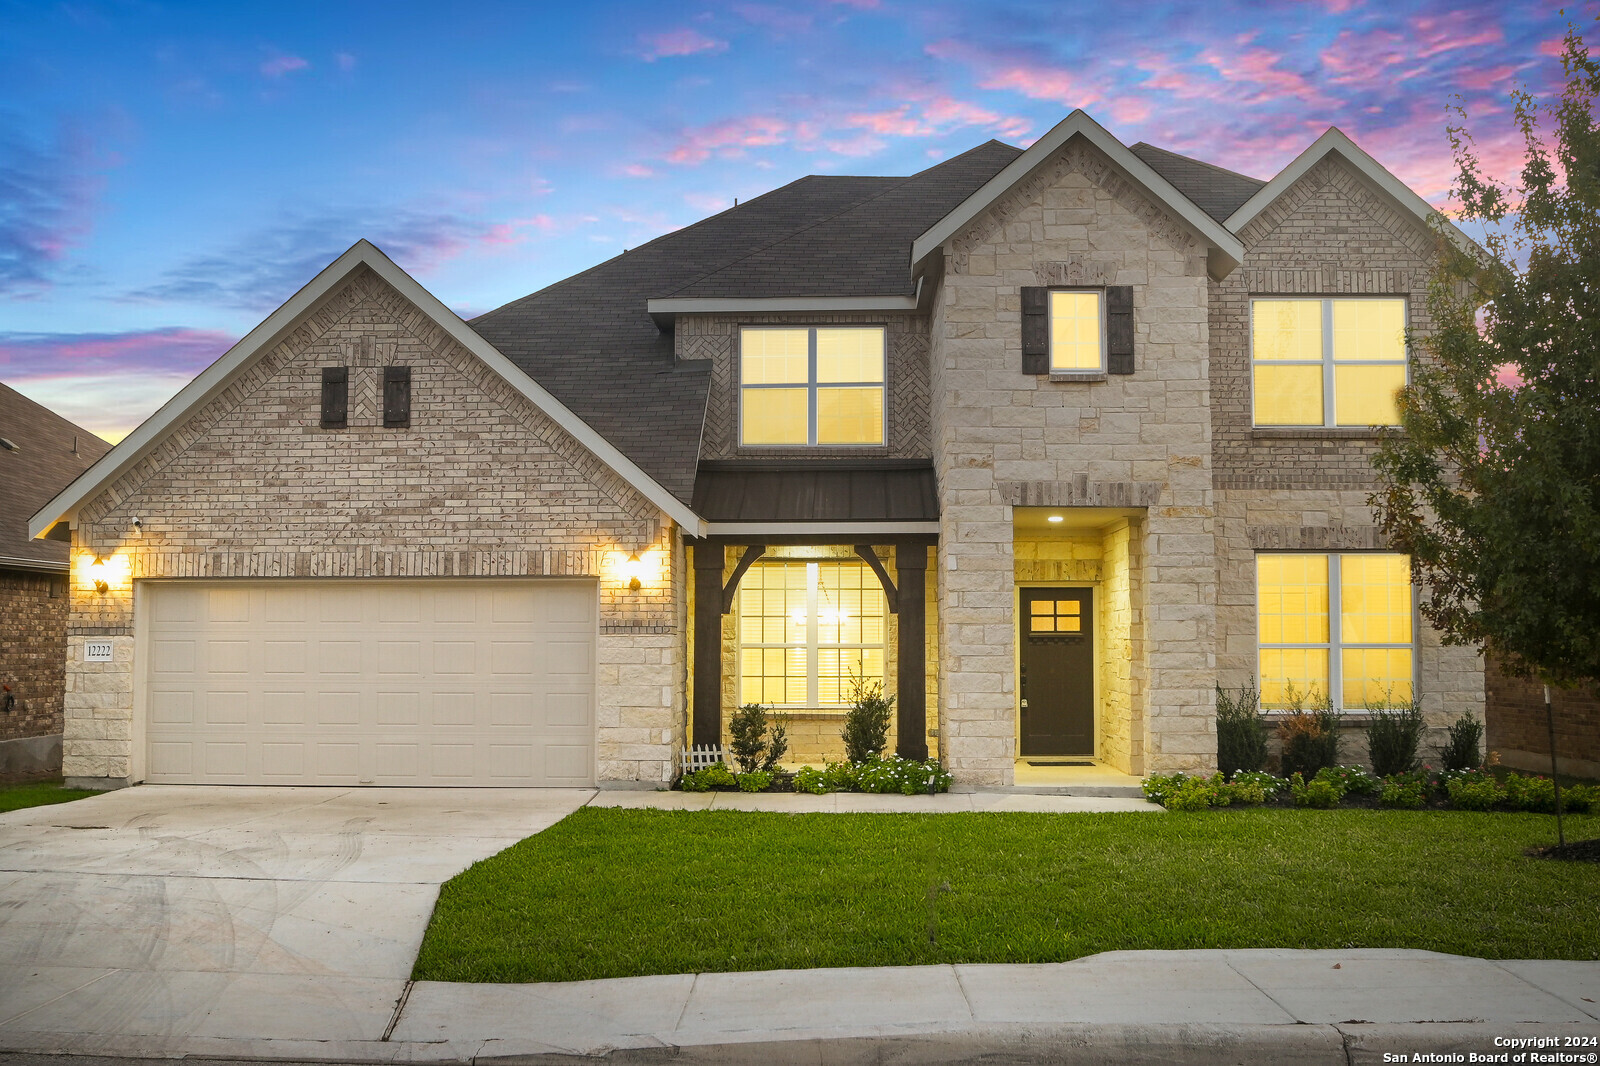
[931,141,1216,786]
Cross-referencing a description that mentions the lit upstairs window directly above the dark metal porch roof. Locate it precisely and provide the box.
[739,327,885,445]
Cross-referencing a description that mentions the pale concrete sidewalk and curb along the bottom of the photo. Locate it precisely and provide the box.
[0,949,1600,1066]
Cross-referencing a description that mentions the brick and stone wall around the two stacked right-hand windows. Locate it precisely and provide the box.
[1210,157,1483,742]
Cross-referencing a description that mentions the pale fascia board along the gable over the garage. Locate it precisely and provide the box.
[27,238,706,538]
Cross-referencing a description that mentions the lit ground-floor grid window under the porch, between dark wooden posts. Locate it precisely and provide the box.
[736,560,888,709]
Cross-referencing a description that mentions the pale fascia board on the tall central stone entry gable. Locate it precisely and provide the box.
[910,109,1245,280]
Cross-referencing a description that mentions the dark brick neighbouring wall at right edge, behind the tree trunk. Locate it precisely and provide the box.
[1483,656,1600,778]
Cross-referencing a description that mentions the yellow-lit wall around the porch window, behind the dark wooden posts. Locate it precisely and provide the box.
[688,544,939,765]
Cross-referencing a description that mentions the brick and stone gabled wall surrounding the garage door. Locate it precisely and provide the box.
[64,267,685,786]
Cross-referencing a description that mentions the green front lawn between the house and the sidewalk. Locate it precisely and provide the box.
[413,807,1600,981]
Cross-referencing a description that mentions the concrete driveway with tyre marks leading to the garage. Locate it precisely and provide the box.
[0,786,594,1053]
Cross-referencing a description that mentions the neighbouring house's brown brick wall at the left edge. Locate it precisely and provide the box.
[0,570,67,741]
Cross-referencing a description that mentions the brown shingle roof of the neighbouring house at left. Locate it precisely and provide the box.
[0,384,110,570]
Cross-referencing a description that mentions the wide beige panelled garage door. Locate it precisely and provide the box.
[138,579,597,786]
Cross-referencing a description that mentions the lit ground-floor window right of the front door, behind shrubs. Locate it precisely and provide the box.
[1256,552,1416,709]
